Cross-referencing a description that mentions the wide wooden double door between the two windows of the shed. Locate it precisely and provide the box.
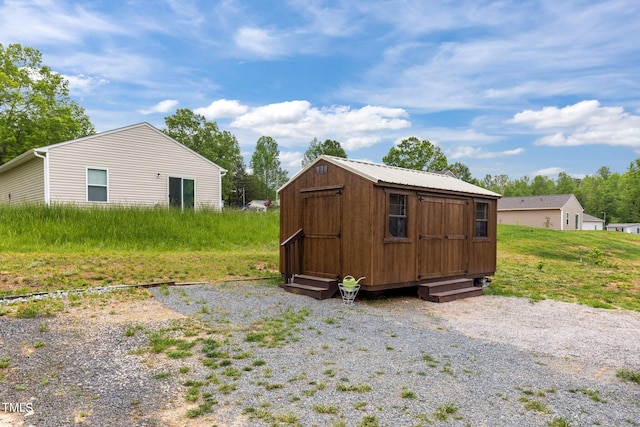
[416,196,469,280]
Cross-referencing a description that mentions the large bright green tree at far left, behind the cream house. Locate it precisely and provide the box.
[0,43,95,165]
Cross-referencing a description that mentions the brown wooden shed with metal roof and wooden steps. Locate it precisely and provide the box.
[279,156,500,302]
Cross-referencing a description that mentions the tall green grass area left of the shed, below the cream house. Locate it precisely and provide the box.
[0,206,279,295]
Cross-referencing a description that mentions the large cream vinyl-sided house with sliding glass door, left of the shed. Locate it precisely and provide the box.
[0,123,226,209]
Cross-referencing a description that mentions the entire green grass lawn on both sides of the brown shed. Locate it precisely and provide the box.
[0,206,640,311]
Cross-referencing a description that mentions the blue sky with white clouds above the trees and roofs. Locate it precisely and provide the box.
[0,0,640,179]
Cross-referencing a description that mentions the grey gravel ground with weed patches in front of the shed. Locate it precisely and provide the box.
[0,284,640,426]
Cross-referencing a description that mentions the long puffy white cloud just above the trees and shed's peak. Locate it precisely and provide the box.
[230,100,411,150]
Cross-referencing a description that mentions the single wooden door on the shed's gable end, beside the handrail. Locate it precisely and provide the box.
[302,190,342,278]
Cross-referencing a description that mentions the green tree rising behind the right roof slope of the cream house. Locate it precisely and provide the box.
[162,108,246,204]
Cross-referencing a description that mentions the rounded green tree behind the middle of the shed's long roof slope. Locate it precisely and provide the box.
[382,136,447,172]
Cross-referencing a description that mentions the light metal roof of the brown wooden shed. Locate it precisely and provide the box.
[278,155,500,198]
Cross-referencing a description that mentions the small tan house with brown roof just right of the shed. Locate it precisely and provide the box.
[498,194,584,230]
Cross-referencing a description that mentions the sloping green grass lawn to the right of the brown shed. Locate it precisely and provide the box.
[486,225,640,311]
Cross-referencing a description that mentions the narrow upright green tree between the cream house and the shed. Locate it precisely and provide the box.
[251,136,287,199]
